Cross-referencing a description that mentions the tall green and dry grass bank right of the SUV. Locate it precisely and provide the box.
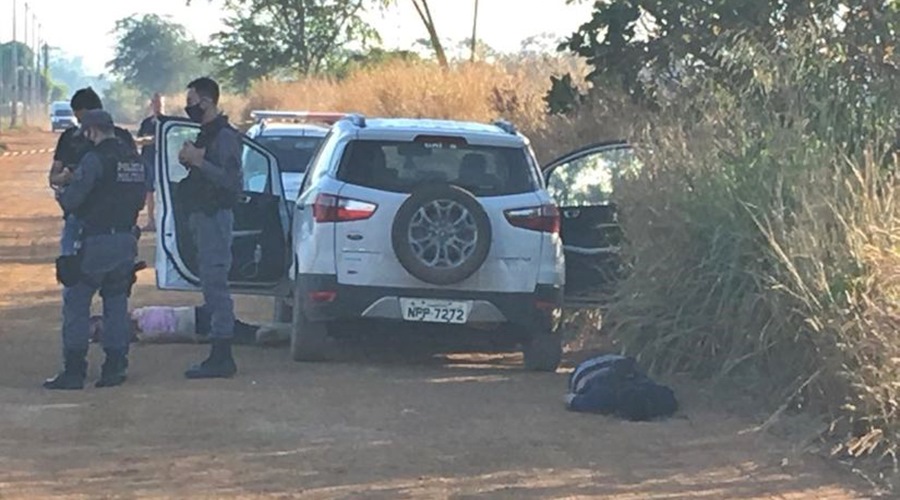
[606,31,900,456]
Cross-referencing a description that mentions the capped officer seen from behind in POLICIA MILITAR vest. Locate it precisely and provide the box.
[44,109,147,389]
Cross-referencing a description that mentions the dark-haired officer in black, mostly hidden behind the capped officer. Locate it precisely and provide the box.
[49,87,137,255]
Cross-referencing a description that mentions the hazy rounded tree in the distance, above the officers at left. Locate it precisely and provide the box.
[107,14,209,94]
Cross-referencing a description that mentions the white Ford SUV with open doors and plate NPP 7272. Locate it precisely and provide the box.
[156,115,632,371]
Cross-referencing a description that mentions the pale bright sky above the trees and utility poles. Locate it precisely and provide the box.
[0,0,593,74]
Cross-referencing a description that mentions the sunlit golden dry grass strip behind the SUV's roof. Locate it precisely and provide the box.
[244,57,622,160]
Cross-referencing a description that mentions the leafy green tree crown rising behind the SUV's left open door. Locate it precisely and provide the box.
[188,0,379,88]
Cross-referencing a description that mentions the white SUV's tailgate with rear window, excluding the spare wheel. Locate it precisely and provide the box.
[335,135,544,293]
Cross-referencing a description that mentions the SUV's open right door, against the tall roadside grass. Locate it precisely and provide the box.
[544,141,640,306]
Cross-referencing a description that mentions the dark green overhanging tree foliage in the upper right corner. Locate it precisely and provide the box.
[555,0,900,108]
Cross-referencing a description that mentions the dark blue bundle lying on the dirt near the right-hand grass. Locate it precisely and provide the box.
[566,354,678,421]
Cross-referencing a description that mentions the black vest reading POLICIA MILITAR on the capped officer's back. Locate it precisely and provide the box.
[75,139,147,231]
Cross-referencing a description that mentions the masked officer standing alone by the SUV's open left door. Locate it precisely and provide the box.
[177,77,243,379]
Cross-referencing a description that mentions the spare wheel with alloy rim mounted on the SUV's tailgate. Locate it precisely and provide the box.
[391,184,492,285]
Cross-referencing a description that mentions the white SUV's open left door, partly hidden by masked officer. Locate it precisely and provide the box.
[156,118,291,295]
